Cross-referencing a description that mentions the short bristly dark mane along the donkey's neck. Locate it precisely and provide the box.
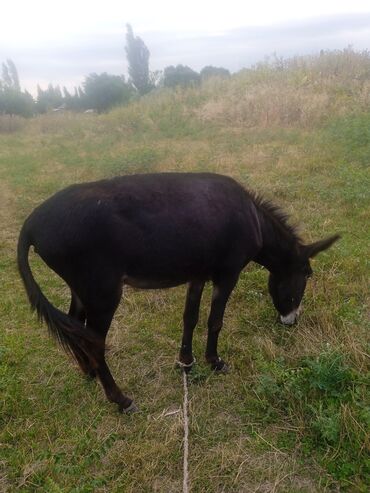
[248,191,303,245]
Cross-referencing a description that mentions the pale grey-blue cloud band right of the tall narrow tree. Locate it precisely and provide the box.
[145,14,370,71]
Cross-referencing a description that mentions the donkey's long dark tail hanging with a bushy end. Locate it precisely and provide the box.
[17,226,104,362]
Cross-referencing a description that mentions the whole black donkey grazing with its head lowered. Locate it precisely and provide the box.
[18,173,339,412]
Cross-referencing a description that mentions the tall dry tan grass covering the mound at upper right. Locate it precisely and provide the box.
[194,49,370,128]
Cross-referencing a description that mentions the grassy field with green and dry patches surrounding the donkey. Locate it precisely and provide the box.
[0,50,370,493]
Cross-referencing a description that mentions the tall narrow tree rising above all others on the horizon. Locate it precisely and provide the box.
[126,24,153,96]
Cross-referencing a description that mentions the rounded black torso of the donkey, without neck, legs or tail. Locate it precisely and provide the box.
[25,173,259,288]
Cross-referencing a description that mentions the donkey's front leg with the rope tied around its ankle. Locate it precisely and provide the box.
[179,281,204,369]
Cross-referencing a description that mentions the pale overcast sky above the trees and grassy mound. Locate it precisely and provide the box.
[0,0,370,93]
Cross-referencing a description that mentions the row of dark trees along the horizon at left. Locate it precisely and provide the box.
[0,24,230,117]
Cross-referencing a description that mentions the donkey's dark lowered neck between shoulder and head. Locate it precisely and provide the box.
[254,199,301,273]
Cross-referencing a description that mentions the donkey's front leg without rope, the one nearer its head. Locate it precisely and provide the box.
[206,276,238,373]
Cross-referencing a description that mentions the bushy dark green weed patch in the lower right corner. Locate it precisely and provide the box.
[256,350,370,491]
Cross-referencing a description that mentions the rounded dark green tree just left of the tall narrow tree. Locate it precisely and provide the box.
[79,72,132,113]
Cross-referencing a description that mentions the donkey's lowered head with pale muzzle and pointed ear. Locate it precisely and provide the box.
[269,235,339,325]
